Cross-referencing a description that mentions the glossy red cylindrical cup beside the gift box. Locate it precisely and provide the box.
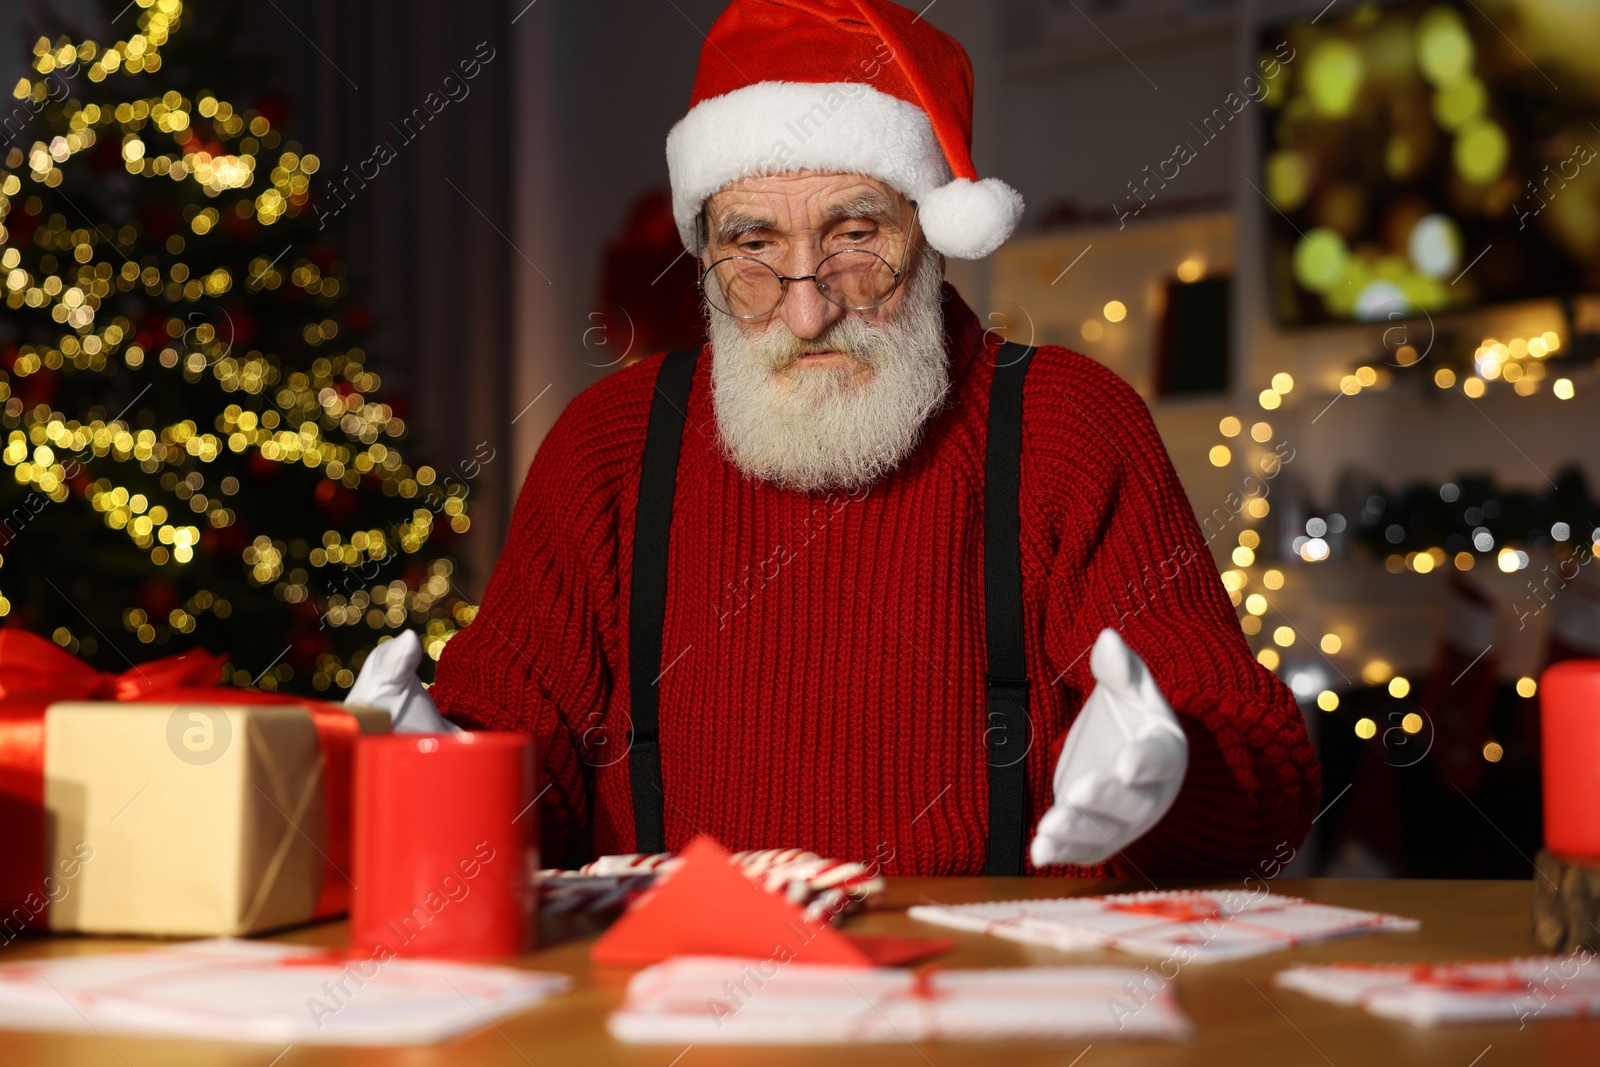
[350,731,539,963]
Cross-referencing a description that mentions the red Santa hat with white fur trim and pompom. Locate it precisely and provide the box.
[667,0,1022,259]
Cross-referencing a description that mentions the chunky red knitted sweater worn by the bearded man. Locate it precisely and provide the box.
[434,286,1318,875]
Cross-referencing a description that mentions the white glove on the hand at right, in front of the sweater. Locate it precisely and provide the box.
[1029,629,1189,867]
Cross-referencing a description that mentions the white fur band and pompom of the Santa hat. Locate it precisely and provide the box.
[667,82,1022,259]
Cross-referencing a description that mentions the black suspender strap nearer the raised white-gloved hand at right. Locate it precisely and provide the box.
[984,341,1034,877]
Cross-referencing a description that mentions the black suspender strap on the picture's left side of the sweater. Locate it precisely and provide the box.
[627,349,699,853]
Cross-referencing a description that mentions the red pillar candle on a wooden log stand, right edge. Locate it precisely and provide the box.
[1539,659,1600,859]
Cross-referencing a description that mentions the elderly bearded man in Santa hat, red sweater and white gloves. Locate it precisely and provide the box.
[350,0,1318,875]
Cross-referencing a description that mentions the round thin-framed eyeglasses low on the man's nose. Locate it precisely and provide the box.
[694,205,917,318]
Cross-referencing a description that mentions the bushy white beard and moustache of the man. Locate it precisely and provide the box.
[706,254,950,491]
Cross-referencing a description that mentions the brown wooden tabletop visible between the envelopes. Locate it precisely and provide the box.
[0,878,1600,1067]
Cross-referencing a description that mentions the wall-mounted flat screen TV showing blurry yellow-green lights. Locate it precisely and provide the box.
[1246,0,1600,325]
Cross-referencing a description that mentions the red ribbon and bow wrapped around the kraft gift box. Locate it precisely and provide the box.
[0,627,360,918]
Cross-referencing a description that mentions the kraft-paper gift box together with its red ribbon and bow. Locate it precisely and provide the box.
[0,629,389,941]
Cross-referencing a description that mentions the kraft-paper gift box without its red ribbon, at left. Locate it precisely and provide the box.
[45,703,387,936]
